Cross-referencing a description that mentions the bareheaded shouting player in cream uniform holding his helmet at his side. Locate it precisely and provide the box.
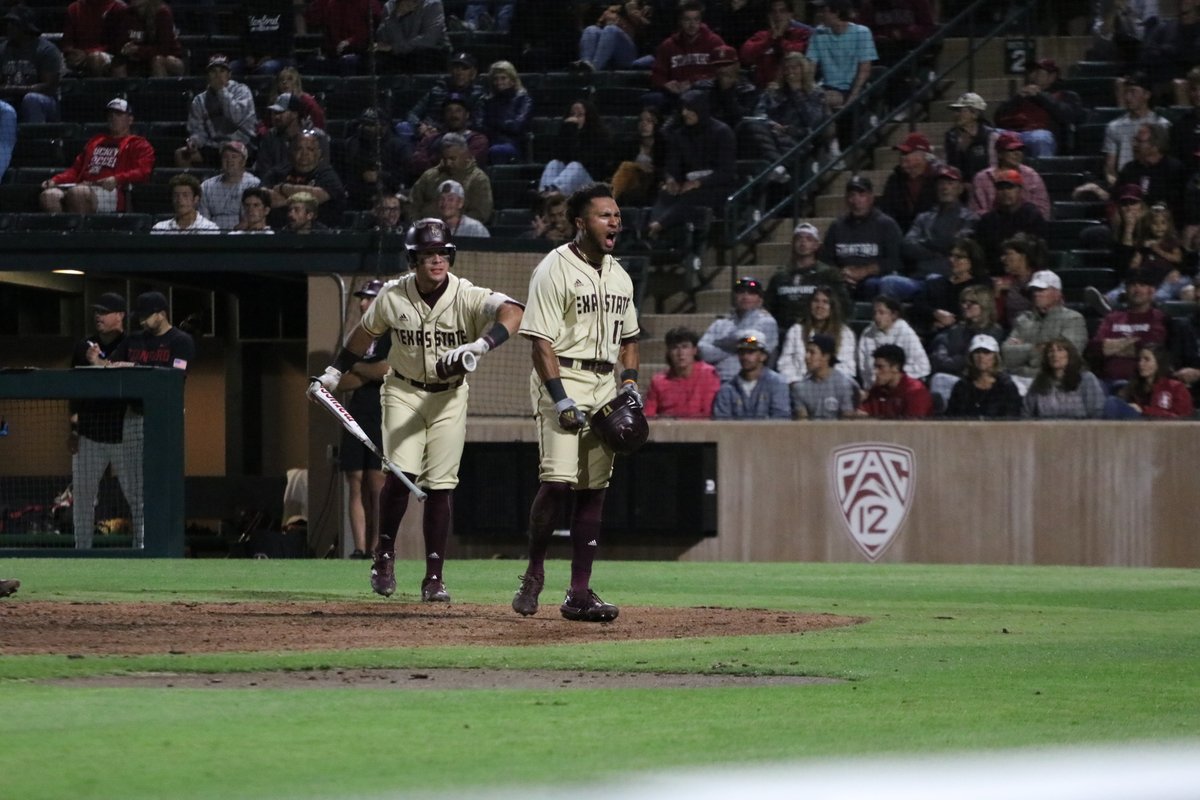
[512,184,641,622]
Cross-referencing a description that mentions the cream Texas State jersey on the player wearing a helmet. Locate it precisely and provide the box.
[362,272,496,384]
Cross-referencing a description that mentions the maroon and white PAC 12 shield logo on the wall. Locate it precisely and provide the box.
[830,441,913,561]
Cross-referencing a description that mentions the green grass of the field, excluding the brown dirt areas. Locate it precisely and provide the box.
[0,559,1200,800]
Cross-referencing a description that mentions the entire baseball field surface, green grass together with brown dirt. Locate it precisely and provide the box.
[0,559,1200,800]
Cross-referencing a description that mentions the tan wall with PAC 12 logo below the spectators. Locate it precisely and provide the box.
[350,420,1200,567]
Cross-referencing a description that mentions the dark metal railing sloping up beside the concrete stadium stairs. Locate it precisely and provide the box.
[722,0,1037,263]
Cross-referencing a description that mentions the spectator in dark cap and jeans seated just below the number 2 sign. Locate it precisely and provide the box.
[996,59,1087,158]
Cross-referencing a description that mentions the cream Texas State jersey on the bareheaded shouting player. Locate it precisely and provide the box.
[517,242,641,363]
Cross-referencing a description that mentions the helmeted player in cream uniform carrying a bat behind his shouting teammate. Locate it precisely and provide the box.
[314,217,523,602]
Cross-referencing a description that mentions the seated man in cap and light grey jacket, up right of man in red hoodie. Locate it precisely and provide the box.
[175,53,258,168]
